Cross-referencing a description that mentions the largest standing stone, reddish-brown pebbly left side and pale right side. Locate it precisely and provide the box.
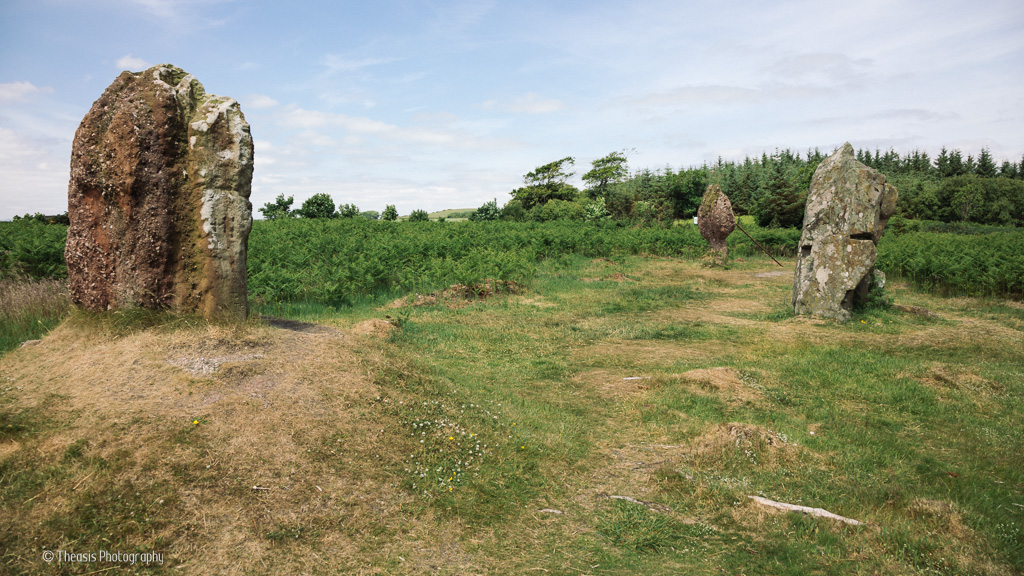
[66,65,253,319]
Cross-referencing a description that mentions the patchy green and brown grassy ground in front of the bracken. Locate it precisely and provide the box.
[0,258,1024,574]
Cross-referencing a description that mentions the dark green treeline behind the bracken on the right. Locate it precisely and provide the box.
[468,148,1024,228]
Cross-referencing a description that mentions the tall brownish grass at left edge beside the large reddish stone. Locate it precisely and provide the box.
[0,278,72,353]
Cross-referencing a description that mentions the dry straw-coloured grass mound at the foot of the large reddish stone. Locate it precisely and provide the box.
[0,321,430,574]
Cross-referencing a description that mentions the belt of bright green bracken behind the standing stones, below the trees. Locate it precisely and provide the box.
[0,218,1024,303]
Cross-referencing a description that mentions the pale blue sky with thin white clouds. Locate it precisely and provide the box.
[0,0,1024,219]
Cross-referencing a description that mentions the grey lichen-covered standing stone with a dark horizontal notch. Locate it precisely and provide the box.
[793,142,897,322]
